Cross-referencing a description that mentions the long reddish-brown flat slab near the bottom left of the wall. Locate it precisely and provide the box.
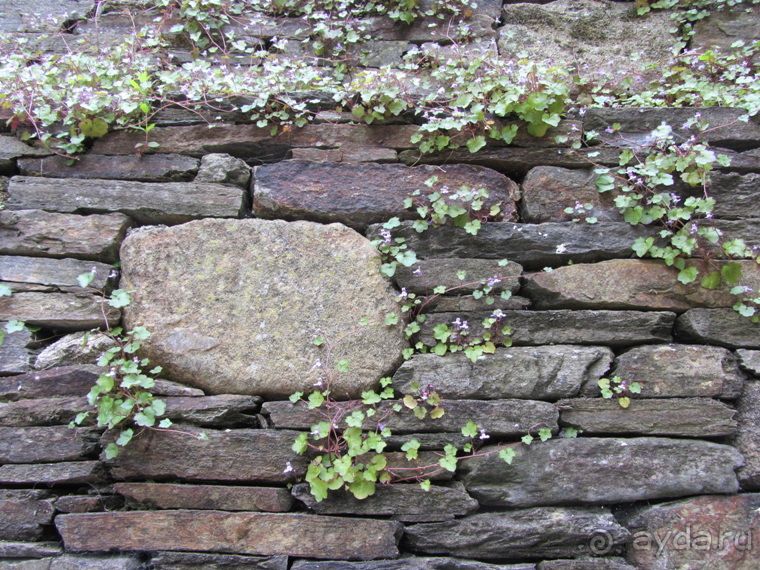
[55,510,402,560]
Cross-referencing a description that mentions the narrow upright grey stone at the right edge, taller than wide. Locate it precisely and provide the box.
[731,382,760,491]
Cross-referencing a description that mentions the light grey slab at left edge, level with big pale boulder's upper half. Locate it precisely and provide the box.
[0,255,112,290]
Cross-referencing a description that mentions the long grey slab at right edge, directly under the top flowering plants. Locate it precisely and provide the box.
[583,107,760,151]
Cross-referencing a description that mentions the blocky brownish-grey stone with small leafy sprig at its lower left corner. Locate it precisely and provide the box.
[583,344,744,400]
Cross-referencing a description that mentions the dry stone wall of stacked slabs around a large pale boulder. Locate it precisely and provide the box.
[0,0,760,570]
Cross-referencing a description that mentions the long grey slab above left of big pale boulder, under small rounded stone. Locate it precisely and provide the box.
[8,176,246,224]
